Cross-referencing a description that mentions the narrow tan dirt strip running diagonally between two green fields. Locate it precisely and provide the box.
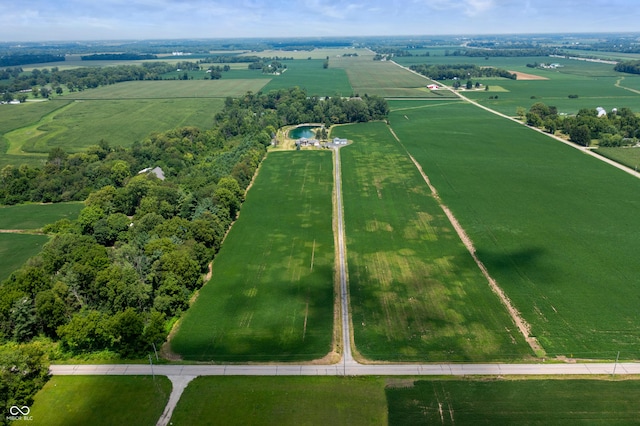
[388,127,545,356]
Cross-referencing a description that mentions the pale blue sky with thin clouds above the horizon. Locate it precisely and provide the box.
[0,0,640,41]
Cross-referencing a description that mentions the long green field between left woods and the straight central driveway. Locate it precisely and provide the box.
[171,151,334,362]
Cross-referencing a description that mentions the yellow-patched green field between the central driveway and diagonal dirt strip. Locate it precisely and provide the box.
[335,123,530,361]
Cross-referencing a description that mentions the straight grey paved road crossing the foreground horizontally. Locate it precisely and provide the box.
[50,362,640,377]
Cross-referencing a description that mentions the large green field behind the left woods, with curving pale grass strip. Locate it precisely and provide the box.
[0,96,224,160]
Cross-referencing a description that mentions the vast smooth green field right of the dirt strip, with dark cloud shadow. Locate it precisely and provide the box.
[390,100,640,359]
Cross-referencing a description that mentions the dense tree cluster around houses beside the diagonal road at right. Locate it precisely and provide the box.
[525,102,640,147]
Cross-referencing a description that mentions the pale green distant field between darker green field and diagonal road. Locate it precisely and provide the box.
[329,52,452,98]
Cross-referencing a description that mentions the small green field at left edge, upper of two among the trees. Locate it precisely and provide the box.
[0,203,84,230]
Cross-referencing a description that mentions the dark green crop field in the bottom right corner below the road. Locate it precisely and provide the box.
[386,380,640,426]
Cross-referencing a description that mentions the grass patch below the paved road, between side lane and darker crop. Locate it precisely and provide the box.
[171,377,387,426]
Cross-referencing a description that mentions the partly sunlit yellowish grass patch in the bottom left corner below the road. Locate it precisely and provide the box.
[28,376,171,426]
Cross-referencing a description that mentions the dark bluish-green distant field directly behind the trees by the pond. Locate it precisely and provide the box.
[255,59,353,96]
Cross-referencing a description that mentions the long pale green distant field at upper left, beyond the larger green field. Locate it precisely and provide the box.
[65,78,267,99]
